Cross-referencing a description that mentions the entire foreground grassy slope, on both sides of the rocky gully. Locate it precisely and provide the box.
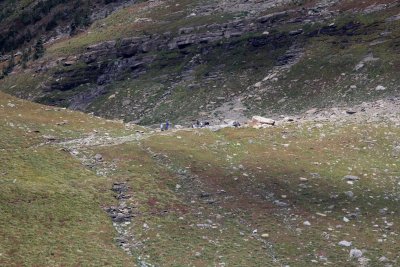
[0,88,400,266]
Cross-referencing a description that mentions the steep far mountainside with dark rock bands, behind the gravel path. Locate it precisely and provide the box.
[0,0,400,124]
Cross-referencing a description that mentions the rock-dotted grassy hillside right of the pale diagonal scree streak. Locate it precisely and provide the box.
[247,7,400,114]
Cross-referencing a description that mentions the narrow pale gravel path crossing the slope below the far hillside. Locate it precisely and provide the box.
[51,96,400,153]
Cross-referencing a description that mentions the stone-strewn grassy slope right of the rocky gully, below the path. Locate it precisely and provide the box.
[79,123,400,266]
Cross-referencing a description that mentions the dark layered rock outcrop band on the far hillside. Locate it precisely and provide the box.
[45,12,294,91]
